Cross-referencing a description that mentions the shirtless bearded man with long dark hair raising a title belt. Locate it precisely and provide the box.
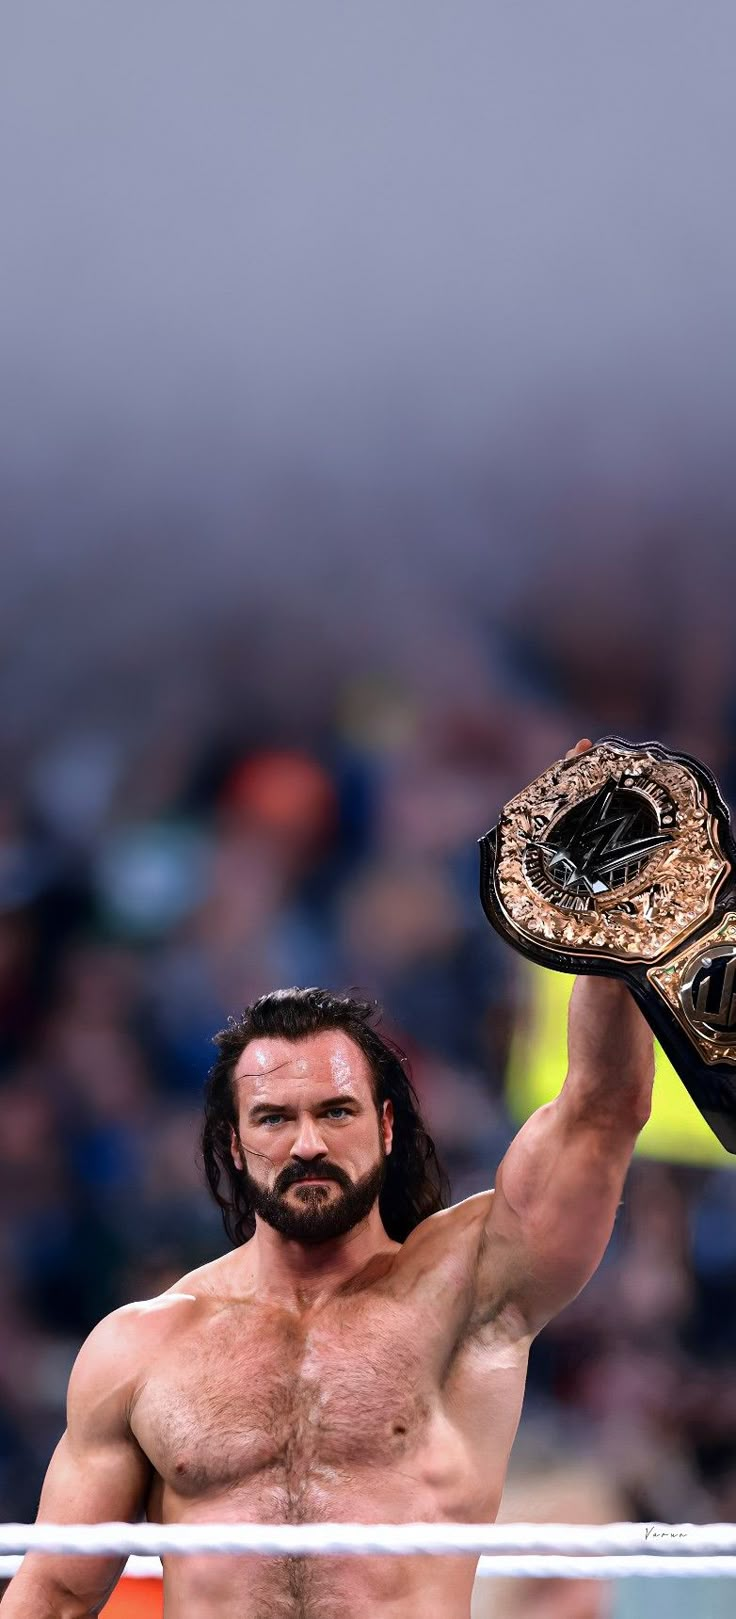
[3,745,654,1619]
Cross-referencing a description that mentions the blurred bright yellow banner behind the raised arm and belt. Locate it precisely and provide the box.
[506,962,736,1169]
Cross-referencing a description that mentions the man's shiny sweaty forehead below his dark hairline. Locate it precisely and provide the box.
[235,1030,370,1091]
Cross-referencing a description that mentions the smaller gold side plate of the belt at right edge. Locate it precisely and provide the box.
[647,911,736,1065]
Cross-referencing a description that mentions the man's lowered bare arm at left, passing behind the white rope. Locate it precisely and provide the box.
[2,1307,150,1619]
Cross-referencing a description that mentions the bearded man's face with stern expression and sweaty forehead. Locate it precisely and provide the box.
[231,1030,393,1243]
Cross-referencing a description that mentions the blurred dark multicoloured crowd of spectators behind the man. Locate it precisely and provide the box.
[0,604,736,1541]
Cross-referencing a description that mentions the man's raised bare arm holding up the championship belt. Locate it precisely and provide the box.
[476,978,654,1336]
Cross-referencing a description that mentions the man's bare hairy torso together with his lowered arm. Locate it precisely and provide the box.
[3,1193,531,1619]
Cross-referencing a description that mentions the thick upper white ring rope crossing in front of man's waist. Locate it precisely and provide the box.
[0,1523,736,1561]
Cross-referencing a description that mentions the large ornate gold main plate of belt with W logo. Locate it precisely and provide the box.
[497,743,730,962]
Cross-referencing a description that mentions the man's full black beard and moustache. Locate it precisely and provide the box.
[243,1143,387,1243]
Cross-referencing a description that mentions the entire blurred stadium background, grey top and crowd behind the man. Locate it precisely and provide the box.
[0,0,736,1616]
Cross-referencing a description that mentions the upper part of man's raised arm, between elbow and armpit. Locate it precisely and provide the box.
[479,1094,637,1334]
